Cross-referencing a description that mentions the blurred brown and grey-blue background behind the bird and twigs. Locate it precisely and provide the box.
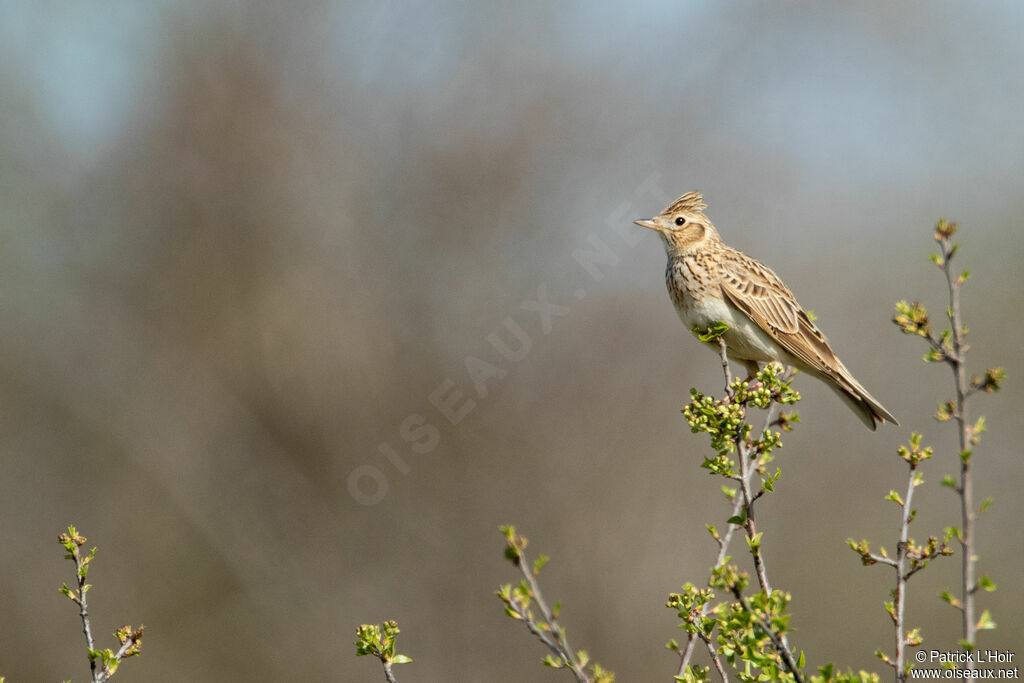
[0,0,1024,681]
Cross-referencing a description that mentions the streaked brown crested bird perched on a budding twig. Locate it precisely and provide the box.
[634,191,899,431]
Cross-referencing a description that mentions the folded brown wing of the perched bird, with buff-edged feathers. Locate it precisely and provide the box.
[719,249,847,381]
